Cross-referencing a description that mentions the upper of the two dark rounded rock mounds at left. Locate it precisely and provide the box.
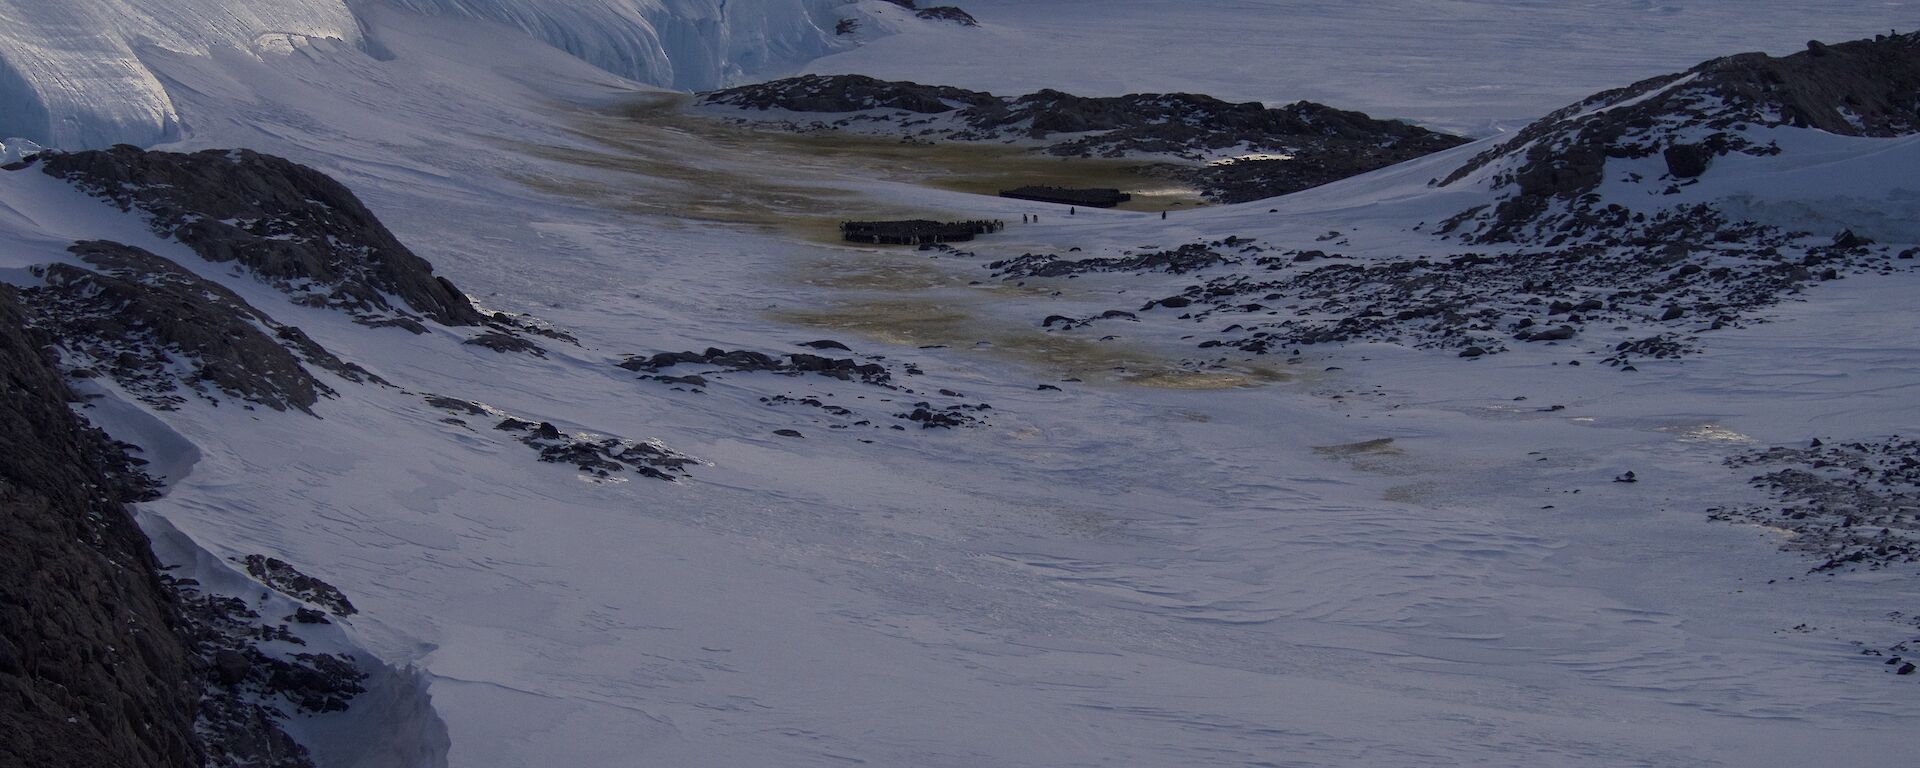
[36,146,482,332]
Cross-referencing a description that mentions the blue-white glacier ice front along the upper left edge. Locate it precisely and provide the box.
[0,0,944,150]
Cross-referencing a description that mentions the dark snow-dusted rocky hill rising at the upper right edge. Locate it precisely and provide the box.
[1442,33,1920,242]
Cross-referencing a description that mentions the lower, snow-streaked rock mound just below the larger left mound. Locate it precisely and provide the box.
[23,240,378,413]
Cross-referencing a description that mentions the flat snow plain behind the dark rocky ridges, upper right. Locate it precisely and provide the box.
[806,0,1920,136]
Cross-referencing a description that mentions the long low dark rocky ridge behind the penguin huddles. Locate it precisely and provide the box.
[701,75,1467,202]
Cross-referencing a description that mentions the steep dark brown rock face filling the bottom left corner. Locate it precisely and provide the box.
[0,286,204,768]
